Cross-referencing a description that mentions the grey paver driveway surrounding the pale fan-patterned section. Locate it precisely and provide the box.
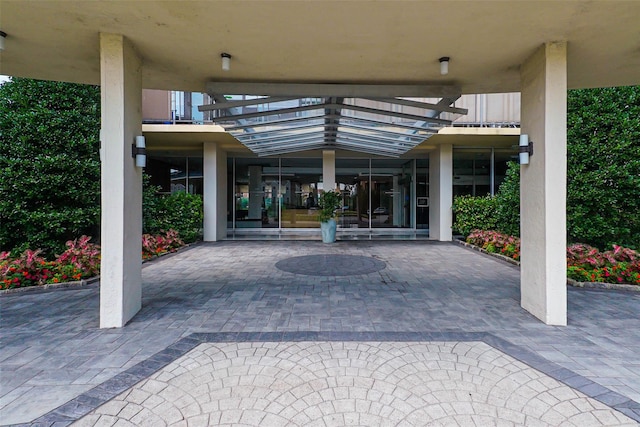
[0,241,640,425]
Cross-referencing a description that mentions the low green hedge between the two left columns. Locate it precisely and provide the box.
[142,177,204,243]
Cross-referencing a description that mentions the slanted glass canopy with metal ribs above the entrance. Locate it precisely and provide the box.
[199,94,466,157]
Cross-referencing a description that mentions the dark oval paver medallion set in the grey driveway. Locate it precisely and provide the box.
[276,255,387,276]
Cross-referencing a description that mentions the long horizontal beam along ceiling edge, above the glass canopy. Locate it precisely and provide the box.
[206,82,462,98]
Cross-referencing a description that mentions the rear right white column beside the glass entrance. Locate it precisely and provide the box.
[429,144,453,242]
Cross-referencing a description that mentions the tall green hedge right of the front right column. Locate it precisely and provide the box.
[568,86,640,249]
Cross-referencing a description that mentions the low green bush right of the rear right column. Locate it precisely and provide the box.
[453,196,497,236]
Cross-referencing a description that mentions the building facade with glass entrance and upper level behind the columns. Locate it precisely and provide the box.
[142,90,520,238]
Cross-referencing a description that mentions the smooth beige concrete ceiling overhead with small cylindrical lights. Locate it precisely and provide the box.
[0,0,640,93]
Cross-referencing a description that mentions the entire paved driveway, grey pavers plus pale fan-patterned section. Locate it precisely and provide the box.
[0,241,640,425]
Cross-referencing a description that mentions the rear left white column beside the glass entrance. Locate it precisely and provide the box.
[203,142,227,242]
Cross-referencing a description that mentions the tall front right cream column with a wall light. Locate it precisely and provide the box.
[520,42,567,325]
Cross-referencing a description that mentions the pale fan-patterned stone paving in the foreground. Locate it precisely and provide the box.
[73,342,637,427]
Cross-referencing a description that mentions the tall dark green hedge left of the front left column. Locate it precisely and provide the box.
[0,78,100,258]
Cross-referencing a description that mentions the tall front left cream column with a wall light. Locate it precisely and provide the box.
[100,34,142,328]
